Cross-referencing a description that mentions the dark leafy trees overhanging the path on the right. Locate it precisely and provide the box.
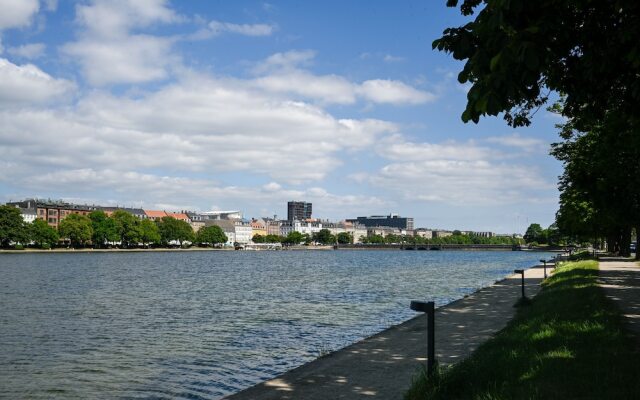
[433,0,640,259]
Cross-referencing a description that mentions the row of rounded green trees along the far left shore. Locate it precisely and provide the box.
[0,206,227,249]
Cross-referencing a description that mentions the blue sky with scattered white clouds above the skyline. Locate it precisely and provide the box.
[0,0,562,233]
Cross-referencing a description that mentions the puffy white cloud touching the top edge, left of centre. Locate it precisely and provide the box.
[62,0,183,85]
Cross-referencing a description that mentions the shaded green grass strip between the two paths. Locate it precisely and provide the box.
[405,261,640,400]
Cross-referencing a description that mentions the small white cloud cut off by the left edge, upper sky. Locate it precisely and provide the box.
[0,58,74,105]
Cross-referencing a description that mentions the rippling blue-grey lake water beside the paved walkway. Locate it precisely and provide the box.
[0,251,550,399]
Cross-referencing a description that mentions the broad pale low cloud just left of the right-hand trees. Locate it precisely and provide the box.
[362,135,555,205]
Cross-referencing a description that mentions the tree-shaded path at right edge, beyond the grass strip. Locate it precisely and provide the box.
[599,259,640,346]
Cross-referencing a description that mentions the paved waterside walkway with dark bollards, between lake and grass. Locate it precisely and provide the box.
[228,266,551,400]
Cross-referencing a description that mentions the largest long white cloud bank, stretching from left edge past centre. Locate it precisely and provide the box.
[0,71,396,183]
